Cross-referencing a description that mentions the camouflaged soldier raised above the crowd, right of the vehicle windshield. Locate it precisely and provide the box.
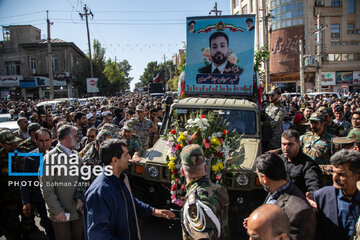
[262,89,286,150]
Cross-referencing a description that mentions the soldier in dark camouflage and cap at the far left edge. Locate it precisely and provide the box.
[0,129,22,240]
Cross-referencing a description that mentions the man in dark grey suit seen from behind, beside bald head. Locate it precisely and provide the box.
[255,153,316,240]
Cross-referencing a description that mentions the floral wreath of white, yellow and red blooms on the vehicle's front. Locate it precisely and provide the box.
[164,112,241,207]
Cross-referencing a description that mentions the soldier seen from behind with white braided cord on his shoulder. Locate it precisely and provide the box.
[180,144,230,239]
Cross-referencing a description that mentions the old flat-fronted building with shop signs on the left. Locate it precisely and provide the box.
[0,25,85,98]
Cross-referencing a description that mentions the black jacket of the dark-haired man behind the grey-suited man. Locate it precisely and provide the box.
[280,149,321,196]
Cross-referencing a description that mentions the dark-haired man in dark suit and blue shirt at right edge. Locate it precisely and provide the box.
[310,149,360,239]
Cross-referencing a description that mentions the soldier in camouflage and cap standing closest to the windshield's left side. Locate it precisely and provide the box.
[130,105,153,154]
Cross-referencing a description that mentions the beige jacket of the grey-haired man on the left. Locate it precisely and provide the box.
[40,144,81,221]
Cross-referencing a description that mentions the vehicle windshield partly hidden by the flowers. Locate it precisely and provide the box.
[170,108,256,135]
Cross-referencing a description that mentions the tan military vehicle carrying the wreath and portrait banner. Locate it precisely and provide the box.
[129,98,266,234]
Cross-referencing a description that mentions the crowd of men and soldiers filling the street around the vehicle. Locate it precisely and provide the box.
[0,89,360,239]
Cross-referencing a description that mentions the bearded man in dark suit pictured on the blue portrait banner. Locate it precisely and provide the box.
[198,32,244,75]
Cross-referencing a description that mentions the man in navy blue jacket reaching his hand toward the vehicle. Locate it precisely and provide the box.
[84,139,175,240]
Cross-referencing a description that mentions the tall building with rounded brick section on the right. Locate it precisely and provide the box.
[230,0,360,93]
